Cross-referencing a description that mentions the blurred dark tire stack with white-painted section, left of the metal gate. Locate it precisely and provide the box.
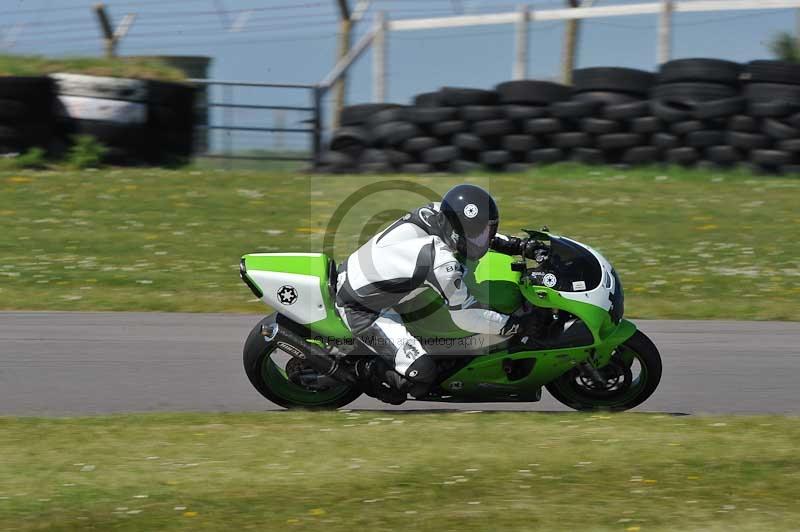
[0,74,195,165]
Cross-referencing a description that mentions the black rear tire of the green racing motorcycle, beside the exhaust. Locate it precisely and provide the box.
[243,314,361,410]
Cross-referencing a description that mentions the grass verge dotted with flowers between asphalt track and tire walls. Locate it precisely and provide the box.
[0,165,800,320]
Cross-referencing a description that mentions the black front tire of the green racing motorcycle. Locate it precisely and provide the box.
[546,331,662,411]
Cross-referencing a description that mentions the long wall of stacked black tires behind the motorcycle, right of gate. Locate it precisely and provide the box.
[320,59,800,174]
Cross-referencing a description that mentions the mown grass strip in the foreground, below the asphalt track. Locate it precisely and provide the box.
[0,411,800,532]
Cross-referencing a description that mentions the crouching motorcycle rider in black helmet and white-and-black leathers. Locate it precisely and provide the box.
[336,184,539,404]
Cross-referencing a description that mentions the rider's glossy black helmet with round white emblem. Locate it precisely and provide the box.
[440,184,500,260]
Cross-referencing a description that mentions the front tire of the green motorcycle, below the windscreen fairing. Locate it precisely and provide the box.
[546,331,661,412]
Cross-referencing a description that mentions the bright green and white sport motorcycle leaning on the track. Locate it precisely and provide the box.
[240,228,662,411]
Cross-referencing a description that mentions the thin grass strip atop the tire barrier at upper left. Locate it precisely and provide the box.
[0,54,186,81]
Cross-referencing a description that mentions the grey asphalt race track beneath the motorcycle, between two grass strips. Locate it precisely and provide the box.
[0,312,800,415]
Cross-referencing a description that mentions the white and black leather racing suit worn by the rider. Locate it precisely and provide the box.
[336,203,517,381]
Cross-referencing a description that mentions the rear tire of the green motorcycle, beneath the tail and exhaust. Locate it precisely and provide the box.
[244,314,361,410]
